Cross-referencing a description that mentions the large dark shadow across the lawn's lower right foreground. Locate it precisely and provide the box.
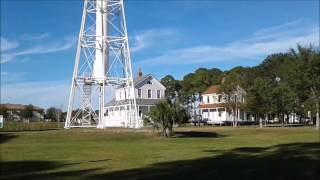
[90,143,320,180]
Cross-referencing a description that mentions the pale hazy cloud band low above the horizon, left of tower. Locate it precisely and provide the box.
[1,81,70,108]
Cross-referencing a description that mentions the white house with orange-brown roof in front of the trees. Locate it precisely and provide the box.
[200,85,247,124]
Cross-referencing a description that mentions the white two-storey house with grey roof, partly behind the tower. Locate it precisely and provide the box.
[103,69,166,127]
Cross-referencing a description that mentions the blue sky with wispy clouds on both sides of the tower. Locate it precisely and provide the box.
[1,0,319,107]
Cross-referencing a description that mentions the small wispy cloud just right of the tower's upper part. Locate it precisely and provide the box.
[130,29,176,52]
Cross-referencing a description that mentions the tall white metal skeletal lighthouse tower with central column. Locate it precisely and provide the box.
[65,0,141,128]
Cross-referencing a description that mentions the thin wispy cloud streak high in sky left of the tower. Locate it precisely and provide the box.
[0,38,76,64]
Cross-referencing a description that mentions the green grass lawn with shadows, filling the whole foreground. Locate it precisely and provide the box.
[1,127,320,180]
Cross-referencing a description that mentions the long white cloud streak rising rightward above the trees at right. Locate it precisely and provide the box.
[136,20,319,67]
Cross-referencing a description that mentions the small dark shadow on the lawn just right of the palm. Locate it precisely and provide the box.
[173,131,224,138]
